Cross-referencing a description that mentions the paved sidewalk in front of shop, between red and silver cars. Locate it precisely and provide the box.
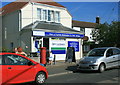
[31,57,76,77]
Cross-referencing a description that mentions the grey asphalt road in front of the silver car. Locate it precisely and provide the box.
[46,66,120,85]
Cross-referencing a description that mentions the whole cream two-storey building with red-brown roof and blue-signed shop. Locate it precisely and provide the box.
[1,0,84,60]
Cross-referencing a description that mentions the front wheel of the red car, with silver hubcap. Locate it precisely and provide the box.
[35,72,46,85]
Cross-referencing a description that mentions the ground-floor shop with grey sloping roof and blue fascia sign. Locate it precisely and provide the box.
[21,22,84,60]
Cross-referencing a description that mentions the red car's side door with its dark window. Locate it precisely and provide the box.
[4,54,35,83]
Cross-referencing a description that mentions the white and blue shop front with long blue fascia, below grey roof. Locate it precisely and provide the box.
[31,30,84,60]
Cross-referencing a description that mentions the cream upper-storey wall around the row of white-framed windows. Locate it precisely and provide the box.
[21,3,72,28]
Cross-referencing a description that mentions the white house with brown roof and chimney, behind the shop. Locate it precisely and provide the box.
[72,19,98,52]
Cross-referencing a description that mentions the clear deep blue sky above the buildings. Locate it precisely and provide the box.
[0,0,120,24]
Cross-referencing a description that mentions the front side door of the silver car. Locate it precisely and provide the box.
[106,49,116,68]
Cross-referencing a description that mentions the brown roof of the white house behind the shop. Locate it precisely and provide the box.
[72,20,97,28]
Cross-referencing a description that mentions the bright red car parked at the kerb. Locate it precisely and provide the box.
[0,53,48,85]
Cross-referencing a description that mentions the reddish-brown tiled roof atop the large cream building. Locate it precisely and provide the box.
[0,0,65,15]
